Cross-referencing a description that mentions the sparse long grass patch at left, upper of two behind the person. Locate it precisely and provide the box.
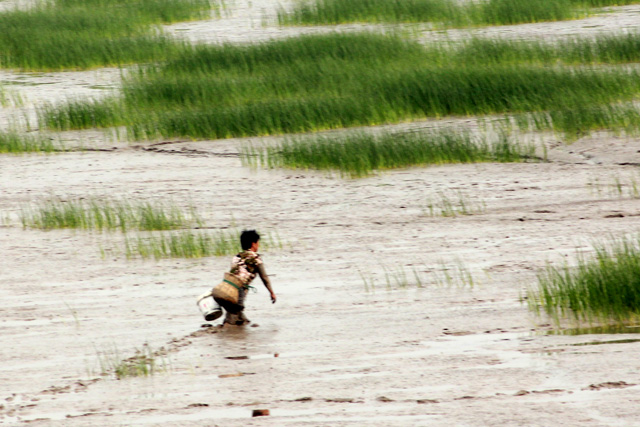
[21,198,200,231]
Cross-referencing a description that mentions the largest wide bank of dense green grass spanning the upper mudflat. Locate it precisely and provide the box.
[40,33,640,139]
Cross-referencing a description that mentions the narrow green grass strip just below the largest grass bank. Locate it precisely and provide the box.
[241,130,534,177]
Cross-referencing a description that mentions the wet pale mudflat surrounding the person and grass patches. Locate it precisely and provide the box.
[0,1,640,426]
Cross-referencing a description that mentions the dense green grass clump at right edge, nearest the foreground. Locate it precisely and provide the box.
[528,239,640,324]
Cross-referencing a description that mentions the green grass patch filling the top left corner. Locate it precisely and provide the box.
[0,0,213,70]
